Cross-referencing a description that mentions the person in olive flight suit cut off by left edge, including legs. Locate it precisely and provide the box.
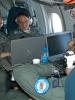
[0,16,29,100]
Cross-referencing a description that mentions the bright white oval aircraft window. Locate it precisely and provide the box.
[49,13,63,33]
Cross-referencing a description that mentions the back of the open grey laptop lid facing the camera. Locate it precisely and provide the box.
[11,36,45,65]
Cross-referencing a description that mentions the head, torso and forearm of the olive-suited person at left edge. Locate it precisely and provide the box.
[0,16,10,58]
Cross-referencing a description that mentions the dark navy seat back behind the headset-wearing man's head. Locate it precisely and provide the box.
[7,7,30,34]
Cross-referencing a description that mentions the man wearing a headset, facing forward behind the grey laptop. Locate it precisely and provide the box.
[9,10,38,39]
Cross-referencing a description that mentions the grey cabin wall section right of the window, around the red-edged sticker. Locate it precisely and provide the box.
[61,7,75,37]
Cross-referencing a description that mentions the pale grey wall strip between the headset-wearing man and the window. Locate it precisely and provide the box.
[27,1,46,34]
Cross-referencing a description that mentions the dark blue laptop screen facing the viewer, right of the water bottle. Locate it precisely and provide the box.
[47,32,73,60]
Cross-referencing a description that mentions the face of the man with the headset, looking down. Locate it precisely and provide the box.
[17,15,29,31]
